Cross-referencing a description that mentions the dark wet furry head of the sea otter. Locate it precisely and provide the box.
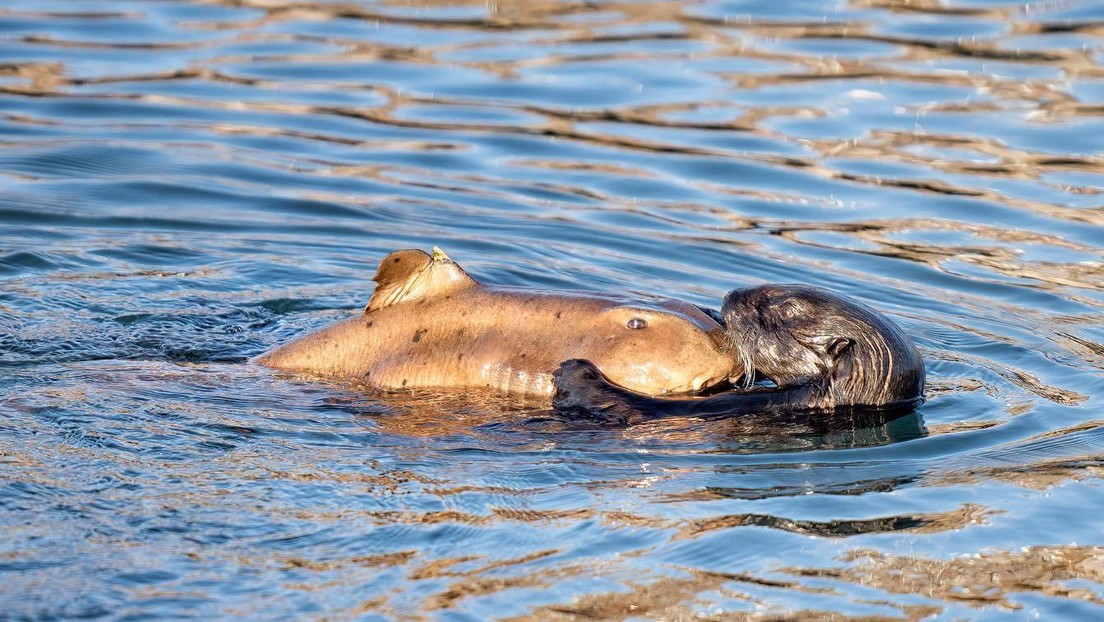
[721,285,924,409]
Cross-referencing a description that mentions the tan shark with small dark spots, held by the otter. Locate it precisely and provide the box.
[255,249,743,399]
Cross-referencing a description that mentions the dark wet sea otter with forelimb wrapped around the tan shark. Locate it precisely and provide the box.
[553,285,924,425]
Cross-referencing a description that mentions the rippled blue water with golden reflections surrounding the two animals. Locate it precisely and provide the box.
[0,0,1104,620]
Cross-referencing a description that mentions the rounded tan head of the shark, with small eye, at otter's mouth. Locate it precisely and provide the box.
[576,299,743,396]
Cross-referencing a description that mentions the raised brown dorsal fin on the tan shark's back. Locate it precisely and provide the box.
[364,246,477,313]
